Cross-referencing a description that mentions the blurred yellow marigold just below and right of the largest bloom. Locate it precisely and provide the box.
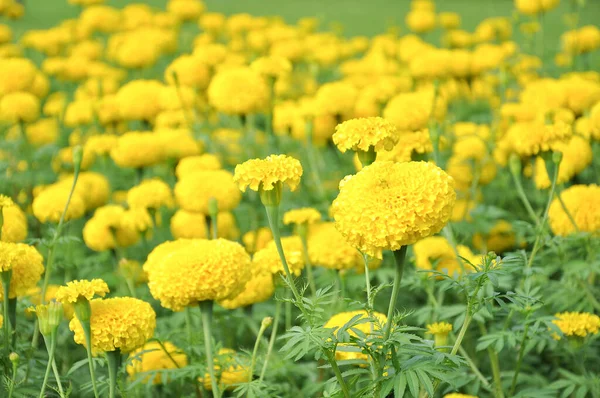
[413,236,478,277]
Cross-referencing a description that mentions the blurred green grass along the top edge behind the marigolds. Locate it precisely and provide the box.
[11,0,600,43]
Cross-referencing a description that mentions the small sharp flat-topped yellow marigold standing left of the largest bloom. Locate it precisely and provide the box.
[233,155,302,192]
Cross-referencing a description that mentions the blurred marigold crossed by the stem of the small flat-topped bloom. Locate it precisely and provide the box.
[252,236,304,276]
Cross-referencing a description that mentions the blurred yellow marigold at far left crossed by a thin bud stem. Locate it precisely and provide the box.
[32,185,86,223]
